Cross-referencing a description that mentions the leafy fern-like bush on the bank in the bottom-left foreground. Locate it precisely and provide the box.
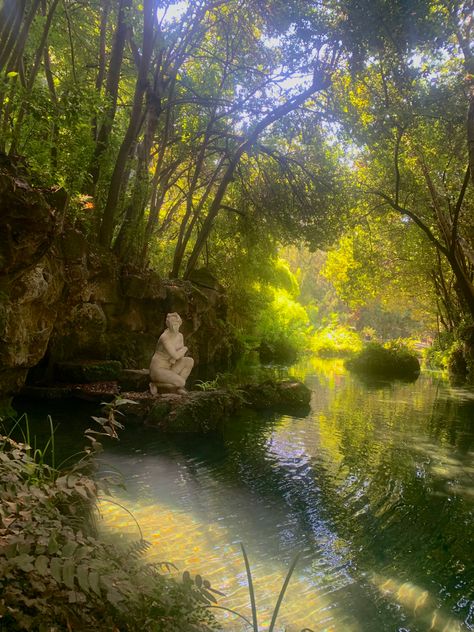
[0,428,216,632]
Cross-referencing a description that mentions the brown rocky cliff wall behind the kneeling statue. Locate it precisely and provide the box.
[0,155,231,408]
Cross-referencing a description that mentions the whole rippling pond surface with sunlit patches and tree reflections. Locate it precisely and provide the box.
[12,361,474,632]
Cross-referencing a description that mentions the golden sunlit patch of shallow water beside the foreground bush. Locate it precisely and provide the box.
[99,496,363,632]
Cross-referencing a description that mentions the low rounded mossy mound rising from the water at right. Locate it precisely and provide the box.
[345,343,420,379]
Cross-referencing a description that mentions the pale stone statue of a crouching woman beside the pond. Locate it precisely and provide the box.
[150,312,194,395]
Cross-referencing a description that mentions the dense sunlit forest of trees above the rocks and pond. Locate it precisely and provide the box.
[0,0,474,362]
